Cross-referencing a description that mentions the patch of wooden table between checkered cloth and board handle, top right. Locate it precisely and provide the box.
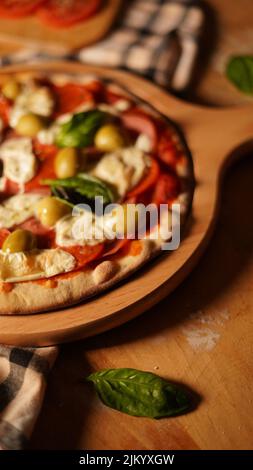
[187,0,253,106]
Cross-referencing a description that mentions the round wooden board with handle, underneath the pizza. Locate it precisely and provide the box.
[0,63,253,345]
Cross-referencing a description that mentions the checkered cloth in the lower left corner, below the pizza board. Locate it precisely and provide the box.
[0,346,58,450]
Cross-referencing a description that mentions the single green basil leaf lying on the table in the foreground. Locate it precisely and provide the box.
[86,369,190,418]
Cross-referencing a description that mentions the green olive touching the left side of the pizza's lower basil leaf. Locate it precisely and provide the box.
[36,196,72,227]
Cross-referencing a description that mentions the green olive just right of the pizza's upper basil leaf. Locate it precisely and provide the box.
[95,124,125,152]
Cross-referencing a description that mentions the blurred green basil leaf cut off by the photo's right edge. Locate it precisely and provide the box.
[226,56,253,95]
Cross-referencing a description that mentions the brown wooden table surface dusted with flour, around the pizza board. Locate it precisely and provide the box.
[0,0,253,450]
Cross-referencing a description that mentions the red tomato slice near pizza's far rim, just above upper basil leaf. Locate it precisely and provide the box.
[53,83,93,115]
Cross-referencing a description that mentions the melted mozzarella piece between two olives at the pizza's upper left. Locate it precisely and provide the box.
[9,83,55,127]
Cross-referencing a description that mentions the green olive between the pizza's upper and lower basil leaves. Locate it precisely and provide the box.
[54,147,79,178]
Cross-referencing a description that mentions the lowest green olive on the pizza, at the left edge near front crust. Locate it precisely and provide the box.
[2,228,37,253]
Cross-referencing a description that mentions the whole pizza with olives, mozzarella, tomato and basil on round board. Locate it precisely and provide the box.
[0,72,194,315]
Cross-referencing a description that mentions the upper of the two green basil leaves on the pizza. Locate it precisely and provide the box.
[55,109,106,147]
